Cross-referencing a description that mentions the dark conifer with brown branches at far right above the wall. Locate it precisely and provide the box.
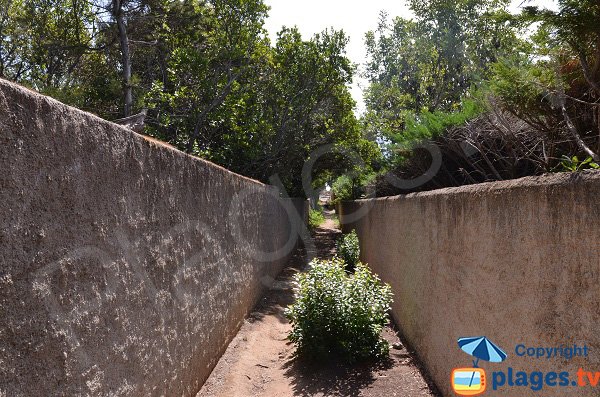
[491,0,600,164]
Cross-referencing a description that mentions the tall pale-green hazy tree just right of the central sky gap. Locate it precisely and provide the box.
[365,0,517,144]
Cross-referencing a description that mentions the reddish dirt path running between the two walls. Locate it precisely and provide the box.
[197,214,435,397]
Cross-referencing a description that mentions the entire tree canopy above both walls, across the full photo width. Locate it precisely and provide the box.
[5,0,600,197]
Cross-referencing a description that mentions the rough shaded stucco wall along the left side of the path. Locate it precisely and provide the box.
[0,80,297,397]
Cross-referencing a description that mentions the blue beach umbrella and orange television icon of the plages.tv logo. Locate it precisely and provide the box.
[450,336,507,396]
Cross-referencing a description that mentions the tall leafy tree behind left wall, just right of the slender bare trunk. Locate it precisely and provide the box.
[146,0,269,155]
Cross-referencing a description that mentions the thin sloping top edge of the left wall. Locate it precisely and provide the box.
[0,78,268,188]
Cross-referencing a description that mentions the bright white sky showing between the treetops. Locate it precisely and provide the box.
[266,0,556,113]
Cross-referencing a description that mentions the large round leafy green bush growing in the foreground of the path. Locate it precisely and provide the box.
[286,258,392,361]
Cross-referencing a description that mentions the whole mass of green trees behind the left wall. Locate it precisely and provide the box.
[0,0,378,196]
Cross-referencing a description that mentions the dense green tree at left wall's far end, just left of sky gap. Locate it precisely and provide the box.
[262,29,374,194]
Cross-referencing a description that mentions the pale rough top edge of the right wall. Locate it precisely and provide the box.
[347,170,600,202]
